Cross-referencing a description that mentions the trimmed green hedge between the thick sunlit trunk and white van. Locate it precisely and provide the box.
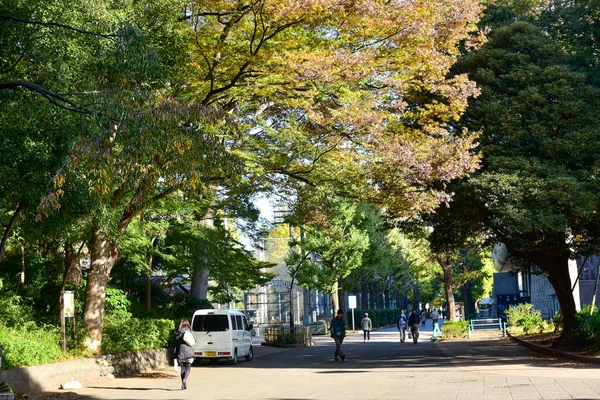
[102,316,175,354]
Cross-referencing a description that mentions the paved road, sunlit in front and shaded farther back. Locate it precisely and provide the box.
[70,321,600,400]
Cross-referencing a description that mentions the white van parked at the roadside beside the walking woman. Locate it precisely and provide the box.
[192,309,254,365]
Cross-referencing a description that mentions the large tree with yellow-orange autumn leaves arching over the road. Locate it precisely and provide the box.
[0,0,480,350]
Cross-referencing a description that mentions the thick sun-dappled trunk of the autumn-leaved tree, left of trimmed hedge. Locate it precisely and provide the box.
[83,227,121,353]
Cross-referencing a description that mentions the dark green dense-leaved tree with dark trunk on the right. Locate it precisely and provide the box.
[456,22,600,332]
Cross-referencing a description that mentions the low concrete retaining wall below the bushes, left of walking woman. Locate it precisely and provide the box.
[0,349,172,394]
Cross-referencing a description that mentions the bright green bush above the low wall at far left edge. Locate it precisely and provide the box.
[0,323,64,369]
